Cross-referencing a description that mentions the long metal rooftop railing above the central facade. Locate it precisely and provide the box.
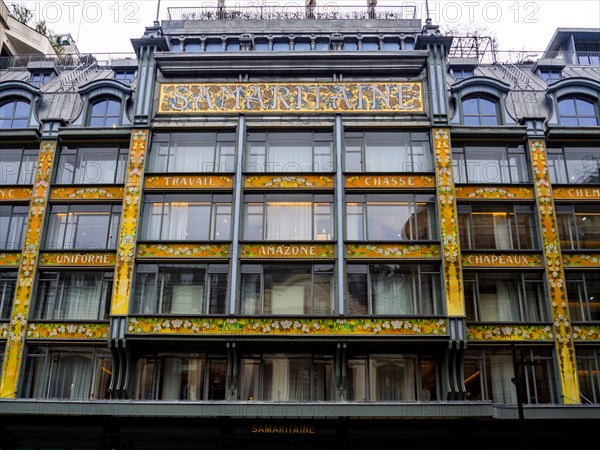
[168,3,417,20]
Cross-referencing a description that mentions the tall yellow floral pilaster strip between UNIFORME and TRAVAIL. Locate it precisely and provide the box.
[110,130,149,316]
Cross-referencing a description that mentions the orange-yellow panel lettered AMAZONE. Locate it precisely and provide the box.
[241,244,335,259]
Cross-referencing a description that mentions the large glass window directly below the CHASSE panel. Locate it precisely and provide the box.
[346,194,437,241]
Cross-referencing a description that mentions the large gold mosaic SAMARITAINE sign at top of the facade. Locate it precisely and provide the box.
[158,81,423,114]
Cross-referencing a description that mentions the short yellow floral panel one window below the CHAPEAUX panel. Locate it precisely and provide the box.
[467,325,554,342]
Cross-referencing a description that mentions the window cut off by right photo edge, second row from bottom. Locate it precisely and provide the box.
[565,271,600,322]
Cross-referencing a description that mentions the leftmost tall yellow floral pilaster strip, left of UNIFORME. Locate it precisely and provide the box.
[0,141,56,398]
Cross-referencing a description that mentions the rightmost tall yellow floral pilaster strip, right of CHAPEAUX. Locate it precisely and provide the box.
[529,140,579,403]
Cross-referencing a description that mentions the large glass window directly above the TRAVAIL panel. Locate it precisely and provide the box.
[147,131,235,173]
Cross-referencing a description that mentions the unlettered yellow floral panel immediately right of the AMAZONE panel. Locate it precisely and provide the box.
[346,244,440,259]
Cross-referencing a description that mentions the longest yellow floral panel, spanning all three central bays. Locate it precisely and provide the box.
[128,317,447,336]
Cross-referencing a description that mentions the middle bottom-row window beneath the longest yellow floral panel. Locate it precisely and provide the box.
[240,354,333,402]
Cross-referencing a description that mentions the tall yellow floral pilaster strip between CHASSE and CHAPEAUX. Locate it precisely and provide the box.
[433,128,465,317]
